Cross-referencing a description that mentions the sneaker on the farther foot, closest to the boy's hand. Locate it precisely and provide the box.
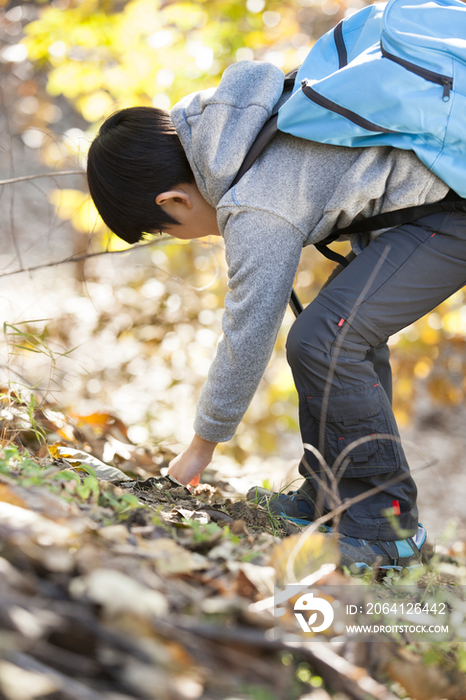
[246,481,332,532]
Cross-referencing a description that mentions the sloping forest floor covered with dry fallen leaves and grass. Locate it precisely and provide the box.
[0,401,466,700]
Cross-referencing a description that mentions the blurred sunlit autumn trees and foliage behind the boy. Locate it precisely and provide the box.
[0,0,466,474]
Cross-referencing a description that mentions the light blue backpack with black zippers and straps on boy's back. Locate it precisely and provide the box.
[231,0,466,315]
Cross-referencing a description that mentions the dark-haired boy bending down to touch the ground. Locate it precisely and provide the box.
[88,62,466,571]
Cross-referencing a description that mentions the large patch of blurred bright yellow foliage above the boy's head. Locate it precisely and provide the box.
[24,0,310,122]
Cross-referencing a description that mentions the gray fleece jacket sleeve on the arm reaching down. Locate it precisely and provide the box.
[194,210,303,442]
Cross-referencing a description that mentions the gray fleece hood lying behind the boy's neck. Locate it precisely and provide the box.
[171,61,284,207]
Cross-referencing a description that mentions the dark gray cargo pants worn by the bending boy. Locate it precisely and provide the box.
[287,213,466,540]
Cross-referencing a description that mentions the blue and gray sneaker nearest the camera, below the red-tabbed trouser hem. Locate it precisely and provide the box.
[338,524,427,576]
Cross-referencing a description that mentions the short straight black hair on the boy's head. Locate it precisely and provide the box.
[87,107,194,243]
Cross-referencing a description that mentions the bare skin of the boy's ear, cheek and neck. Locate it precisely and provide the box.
[155,183,221,240]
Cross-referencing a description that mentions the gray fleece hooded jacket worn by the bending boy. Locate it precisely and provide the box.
[171,61,448,442]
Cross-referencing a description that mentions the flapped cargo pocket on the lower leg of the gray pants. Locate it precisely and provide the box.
[306,384,401,478]
